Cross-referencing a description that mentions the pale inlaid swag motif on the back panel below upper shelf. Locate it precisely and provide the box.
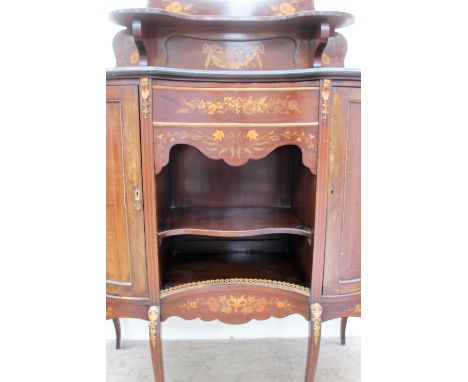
[202,44,265,70]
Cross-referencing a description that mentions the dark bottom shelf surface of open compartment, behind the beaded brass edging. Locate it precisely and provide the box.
[164,253,307,289]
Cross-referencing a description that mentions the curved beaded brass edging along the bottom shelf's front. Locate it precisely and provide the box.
[161,279,310,298]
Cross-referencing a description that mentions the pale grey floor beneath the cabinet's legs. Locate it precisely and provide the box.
[107,338,361,382]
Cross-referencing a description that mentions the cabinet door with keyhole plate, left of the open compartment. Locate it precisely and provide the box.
[106,85,148,299]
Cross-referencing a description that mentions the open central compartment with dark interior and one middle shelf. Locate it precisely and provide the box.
[156,145,316,288]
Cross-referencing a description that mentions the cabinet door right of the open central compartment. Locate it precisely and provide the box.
[323,85,361,295]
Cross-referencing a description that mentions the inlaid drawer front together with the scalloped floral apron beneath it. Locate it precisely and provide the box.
[153,83,319,173]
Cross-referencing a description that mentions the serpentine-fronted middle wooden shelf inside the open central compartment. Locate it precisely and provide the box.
[159,207,312,239]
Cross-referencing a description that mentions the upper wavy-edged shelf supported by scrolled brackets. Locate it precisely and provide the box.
[110,8,354,30]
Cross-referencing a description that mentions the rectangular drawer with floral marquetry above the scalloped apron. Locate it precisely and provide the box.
[153,83,319,126]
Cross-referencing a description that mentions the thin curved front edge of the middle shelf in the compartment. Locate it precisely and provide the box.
[158,227,313,239]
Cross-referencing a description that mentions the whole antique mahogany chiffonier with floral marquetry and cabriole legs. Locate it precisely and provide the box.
[106,0,361,381]
